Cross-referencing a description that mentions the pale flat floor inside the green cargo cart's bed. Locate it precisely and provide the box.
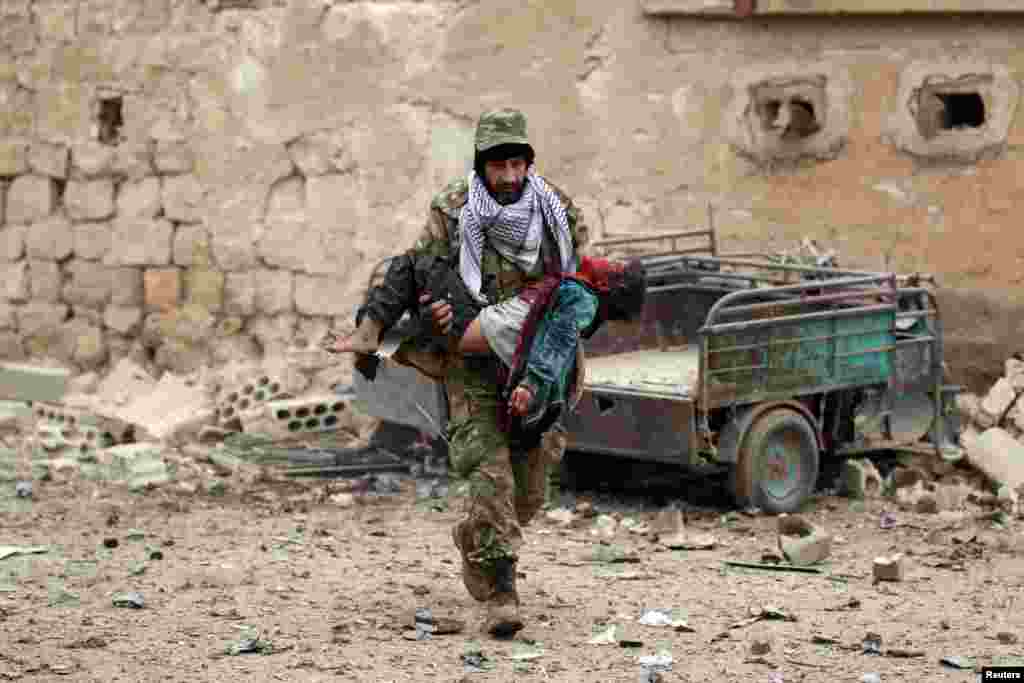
[585,344,700,398]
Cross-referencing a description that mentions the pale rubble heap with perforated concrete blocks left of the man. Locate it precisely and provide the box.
[0,347,377,493]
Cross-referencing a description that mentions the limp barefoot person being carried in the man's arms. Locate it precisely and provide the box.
[329,252,646,427]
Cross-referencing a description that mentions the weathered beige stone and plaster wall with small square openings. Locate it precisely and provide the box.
[6,0,1024,383]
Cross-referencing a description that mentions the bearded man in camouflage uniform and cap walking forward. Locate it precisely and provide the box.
[395,110,588,636]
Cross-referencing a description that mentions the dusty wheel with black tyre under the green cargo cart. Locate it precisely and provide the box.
[732,408,818,514]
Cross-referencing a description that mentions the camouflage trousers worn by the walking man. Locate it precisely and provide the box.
[445,359,565,600]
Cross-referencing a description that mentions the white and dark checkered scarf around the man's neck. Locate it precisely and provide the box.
[459,171,575,302]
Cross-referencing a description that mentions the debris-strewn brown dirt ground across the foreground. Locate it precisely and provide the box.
[0,466,1024,683]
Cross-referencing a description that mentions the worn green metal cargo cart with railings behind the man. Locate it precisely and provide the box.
[354,229,957,513]
